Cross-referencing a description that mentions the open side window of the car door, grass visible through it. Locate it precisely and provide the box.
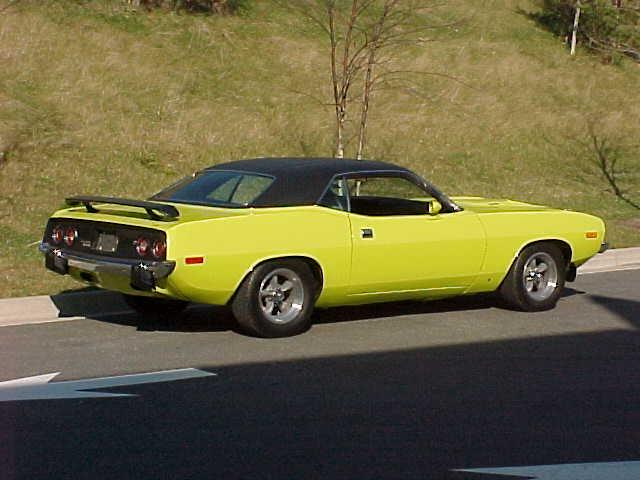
[347,176,432,216]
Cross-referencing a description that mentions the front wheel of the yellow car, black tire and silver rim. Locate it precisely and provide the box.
[499,243,566,312]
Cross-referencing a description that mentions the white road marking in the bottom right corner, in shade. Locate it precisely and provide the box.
[454,461,640,480]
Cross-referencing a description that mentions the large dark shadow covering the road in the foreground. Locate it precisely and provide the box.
[0,331,640,480]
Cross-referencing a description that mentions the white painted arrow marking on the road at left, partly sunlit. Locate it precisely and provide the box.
[0,368,217,402]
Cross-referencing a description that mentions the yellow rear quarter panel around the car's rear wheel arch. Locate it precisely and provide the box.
[167,206,351,306]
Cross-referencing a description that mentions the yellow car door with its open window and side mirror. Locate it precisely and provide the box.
[346,174,485,301]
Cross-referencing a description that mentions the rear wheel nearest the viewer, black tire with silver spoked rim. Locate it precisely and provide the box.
[231,259,318,338]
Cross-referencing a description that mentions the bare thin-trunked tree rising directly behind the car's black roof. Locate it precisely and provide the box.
[280,0,456,159]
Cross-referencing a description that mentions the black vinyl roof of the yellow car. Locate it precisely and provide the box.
[205,158,413,207]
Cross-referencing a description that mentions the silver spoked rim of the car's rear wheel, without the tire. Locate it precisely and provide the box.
[258,268,304,324]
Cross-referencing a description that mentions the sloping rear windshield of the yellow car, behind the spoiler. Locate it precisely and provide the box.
[151,170,274,207]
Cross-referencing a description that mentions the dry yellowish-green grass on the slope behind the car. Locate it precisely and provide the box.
[0,0,640,297]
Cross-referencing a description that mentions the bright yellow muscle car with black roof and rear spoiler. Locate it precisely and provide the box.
[40,158,606,337]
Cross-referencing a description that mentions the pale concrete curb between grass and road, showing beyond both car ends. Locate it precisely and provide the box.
[0,247,640,327]
